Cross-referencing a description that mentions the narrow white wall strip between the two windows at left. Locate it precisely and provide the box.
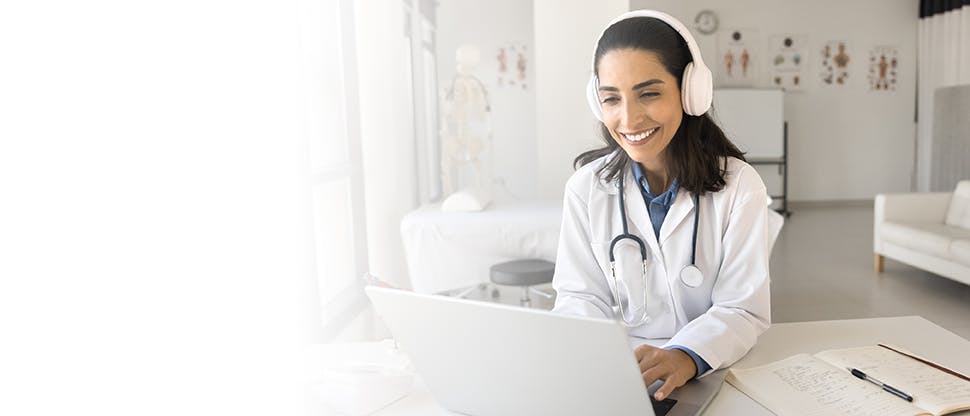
[354,0,417,287]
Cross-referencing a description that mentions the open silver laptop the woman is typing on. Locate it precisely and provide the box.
[365,286,724,416]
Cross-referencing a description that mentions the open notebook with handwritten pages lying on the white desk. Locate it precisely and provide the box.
[726,346,970,416]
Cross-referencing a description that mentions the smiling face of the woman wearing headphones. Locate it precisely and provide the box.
[598,49,684,170]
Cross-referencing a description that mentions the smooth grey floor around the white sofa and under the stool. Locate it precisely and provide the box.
[468,203,970,339]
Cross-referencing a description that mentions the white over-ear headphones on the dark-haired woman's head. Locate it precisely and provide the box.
[586,10,714,121]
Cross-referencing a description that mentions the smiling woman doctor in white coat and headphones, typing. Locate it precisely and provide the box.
[553,10,770,400]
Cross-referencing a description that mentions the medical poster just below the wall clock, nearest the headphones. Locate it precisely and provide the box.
[707,29,758,87]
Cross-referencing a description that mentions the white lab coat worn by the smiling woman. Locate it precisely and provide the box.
[552,154,771,374]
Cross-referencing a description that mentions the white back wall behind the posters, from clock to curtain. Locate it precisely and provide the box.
[630,0,919,201]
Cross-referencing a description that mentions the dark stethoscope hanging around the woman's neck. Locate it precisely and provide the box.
[610,178,704,328]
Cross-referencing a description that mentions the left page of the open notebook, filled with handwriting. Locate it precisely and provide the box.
[726,354,927,416]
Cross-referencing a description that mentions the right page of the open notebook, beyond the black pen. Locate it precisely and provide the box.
[815,345,970,415]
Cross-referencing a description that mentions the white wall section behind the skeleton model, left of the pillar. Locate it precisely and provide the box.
[436,0,538,198]
